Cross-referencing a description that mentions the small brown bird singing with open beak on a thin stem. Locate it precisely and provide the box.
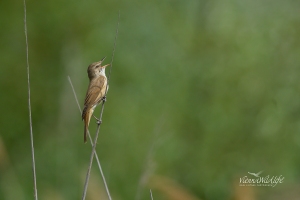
[82,57,110,143]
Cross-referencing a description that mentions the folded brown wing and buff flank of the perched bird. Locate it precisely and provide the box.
[84,76,106,107]
